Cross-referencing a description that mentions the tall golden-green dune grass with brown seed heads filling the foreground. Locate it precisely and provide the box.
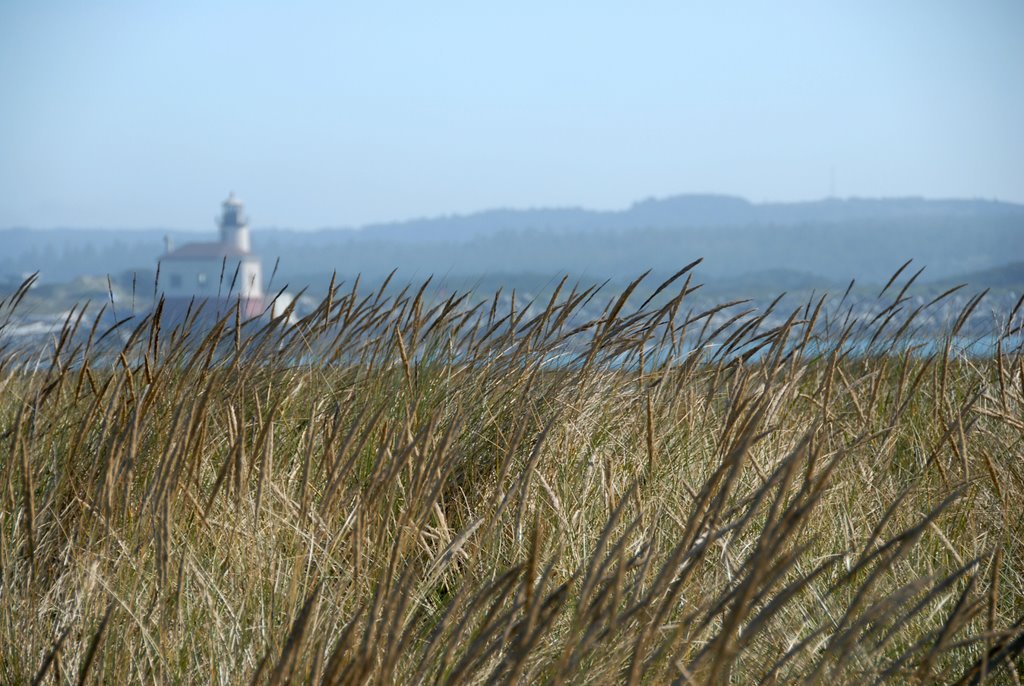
[0,272,1024,684]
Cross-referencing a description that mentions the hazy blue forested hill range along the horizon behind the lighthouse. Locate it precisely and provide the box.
[0,195,1024,288]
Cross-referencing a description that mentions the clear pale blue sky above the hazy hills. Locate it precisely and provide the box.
[0,0,1024,229]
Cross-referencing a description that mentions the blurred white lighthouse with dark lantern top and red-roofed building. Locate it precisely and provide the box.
[159,192,265,317]
